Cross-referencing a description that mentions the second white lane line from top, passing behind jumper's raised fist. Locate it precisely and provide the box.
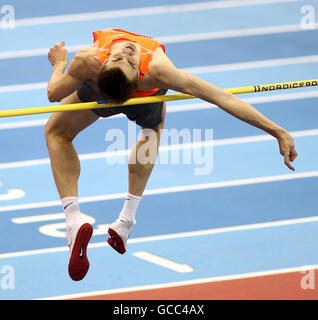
[0,23,318,60]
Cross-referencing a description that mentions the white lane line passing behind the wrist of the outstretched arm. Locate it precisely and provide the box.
[0,129,318,170]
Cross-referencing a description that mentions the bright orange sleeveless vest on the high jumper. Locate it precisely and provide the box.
[93,28,166,97]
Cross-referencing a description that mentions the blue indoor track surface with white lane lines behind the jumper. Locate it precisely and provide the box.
[0,0,318,299]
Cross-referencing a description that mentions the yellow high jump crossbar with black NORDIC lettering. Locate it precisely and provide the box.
[0,79,318,118]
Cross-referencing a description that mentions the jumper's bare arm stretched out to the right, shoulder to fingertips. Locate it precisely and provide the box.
[153,58,297,170]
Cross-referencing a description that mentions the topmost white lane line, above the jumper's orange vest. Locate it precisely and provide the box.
[11,0,301,27]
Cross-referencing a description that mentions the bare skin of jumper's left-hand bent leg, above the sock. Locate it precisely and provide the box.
[45,92,99,199]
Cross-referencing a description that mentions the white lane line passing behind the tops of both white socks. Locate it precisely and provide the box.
[0,171,318,212]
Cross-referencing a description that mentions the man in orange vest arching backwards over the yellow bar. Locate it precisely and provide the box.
[45,29,297,280]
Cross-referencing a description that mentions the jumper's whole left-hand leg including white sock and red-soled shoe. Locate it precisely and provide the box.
[45,92,98,281]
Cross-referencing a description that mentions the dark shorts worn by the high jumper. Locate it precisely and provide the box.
[77,79,168,129]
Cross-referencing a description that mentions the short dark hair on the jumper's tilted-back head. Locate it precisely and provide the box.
[97,66,138,104]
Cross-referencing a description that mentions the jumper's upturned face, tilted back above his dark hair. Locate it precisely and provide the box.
[104,41,141,80]
